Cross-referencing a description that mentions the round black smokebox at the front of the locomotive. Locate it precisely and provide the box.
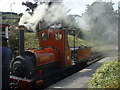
[11,57,35,78]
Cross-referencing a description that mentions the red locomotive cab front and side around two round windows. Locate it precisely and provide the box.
[40,29,72,66]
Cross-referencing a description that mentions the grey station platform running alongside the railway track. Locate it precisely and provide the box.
[47,57,117,89]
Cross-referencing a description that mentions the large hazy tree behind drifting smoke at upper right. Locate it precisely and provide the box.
[82,2,118,43]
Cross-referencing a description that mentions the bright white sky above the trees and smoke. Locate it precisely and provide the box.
[0,0,120,15]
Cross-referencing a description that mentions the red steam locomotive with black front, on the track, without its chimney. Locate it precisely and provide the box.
[10,26,91,89]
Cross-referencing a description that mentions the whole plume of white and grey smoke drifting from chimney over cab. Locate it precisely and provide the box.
[19,3,78,31]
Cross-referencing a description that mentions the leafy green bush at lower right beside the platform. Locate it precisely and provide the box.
[89,59,120,88]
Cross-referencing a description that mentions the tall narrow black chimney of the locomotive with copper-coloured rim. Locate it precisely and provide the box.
[19,25,25,56]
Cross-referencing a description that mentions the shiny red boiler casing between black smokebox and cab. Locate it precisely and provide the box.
[29,48,59,66]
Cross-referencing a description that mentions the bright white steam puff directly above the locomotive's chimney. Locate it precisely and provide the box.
[19,4,48,30]
